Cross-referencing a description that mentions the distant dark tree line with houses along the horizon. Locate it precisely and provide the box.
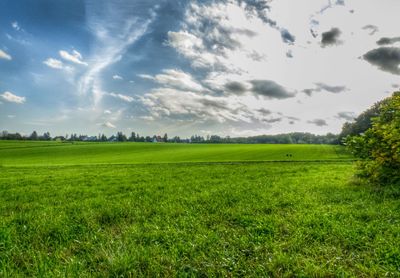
[0,131,339,144]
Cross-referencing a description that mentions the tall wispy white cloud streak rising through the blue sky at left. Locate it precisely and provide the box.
[78,1,154,110]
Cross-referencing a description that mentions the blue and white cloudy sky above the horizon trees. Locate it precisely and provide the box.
[0,0,400,137]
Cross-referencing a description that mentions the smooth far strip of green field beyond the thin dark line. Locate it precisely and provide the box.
[0,141,351,166]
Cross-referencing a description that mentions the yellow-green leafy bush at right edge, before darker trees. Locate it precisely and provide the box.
[346,92,400,184]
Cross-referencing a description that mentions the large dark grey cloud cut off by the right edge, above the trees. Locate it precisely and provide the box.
[363,47,400,74]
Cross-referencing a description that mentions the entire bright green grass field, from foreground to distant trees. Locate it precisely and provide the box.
[0,141,400,277]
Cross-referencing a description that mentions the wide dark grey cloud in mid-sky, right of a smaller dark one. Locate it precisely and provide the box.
[250,80,295,99]
